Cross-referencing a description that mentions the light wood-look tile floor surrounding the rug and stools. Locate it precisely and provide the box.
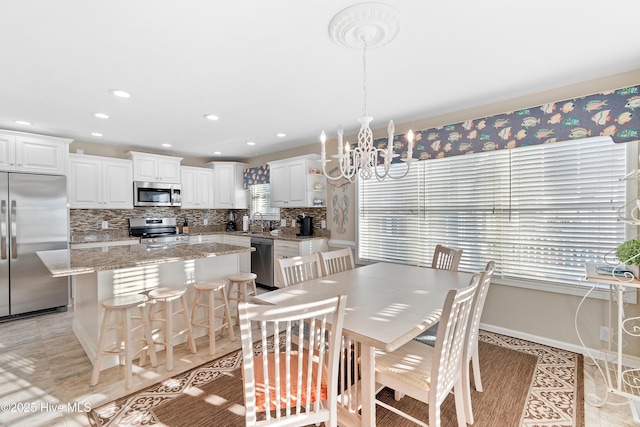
[0,310,640,427]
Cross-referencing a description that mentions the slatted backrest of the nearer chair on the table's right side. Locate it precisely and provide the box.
[429,272,484,406]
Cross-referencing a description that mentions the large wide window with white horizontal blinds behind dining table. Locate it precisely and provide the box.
[356,138,630,285]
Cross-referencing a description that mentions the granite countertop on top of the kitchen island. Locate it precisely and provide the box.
[37,243,255,277]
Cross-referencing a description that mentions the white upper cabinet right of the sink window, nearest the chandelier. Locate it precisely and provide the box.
[269,155,327,208]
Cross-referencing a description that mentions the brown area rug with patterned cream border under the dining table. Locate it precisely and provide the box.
[88,331,584,427]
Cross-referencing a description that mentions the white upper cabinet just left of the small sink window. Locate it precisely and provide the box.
[207,162,249,209]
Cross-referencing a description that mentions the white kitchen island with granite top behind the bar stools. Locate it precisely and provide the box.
[37,243,254,369]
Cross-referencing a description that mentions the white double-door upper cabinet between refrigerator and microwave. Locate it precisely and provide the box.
[67,154,133,209]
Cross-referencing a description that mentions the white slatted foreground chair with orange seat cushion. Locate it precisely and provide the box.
[238,295,347,426]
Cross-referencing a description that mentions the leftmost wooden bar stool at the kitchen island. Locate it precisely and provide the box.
[91,294,158,388]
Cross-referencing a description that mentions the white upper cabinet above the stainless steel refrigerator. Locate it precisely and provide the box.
[0,130,71,175]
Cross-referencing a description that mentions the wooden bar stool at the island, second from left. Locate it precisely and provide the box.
[149,288,196,371]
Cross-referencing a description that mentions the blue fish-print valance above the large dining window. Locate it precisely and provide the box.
[374,86,640,162]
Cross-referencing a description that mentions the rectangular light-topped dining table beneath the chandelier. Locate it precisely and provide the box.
[255,262,472,426]
